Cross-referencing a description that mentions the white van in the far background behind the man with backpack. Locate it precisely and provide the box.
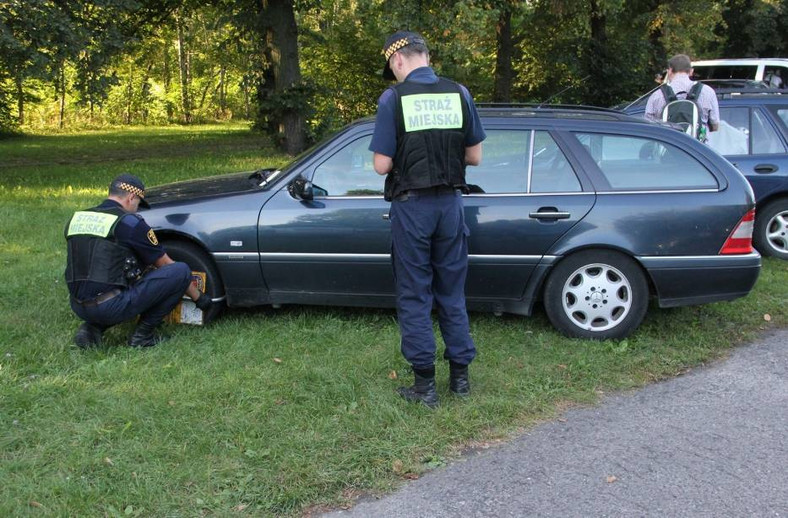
[692,58,788,88]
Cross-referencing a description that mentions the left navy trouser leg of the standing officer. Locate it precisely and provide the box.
[391,198,435,368]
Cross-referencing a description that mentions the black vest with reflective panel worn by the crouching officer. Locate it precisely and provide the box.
[64,207,136,295]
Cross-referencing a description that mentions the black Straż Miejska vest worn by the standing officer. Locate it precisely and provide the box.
[387,78,470,196]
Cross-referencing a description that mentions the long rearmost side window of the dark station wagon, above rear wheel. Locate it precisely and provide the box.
[575,133,718,190]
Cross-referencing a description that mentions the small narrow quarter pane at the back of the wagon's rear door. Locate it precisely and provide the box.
[530,131,582,192]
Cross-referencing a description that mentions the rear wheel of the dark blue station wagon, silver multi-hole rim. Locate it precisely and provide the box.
[544,250,649,340]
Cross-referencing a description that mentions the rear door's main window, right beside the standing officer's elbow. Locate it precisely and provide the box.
[465,130,531,194]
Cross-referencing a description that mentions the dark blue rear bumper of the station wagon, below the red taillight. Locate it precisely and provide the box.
[637,252,761,308]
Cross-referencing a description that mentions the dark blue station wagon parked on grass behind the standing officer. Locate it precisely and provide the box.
[139,107,761,339]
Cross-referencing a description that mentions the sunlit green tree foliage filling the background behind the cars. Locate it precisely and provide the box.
[0,0,788,136]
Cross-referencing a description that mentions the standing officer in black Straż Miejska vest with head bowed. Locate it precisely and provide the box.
[369,31,486,408]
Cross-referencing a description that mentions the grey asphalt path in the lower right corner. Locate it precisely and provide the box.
[324,329,788,518]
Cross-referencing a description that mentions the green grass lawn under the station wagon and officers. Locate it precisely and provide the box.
[0,124,788,516]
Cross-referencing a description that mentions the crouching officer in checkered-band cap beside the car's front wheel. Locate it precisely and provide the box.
[65,174,212,348]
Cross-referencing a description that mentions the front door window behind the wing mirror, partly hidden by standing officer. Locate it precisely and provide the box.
[312,135,384,196]
